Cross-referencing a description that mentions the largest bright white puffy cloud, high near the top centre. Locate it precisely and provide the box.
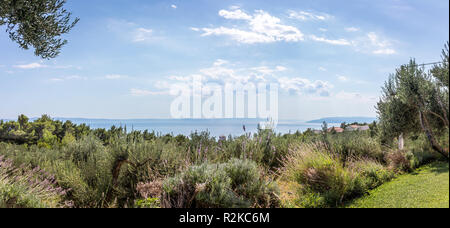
[196,9,304,44]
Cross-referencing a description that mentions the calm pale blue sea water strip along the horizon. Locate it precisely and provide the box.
[51,118,340,137]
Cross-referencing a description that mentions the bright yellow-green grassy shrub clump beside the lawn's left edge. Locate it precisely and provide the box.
[282,144,391,207]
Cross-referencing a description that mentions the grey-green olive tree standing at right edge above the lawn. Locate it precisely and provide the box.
[376,42,449,159]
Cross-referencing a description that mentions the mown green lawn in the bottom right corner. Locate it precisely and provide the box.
[349,162,449,208]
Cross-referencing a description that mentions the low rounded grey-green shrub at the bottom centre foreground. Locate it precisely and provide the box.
[162,159,279,208]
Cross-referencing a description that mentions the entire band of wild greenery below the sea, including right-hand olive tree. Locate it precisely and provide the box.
[0,45,449,208]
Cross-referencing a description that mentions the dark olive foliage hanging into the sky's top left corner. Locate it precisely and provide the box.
[0,0,79,59]
